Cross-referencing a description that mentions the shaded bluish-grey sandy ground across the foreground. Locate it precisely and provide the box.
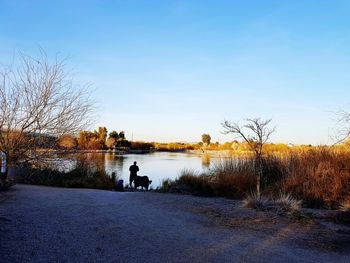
[0,185,350,263]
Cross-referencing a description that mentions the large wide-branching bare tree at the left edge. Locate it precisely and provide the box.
[0,53,92,179]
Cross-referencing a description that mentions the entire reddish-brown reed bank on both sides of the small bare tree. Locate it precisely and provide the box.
[160,147,350,208]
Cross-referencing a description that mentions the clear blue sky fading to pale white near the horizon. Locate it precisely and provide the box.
[0,0,350,144]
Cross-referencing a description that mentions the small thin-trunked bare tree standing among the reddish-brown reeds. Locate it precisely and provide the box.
[221,118,275,196]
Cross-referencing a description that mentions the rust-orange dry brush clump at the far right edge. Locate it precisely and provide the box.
[282,148,350,208]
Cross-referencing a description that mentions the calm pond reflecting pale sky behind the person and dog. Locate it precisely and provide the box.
[83,152,213,188]
